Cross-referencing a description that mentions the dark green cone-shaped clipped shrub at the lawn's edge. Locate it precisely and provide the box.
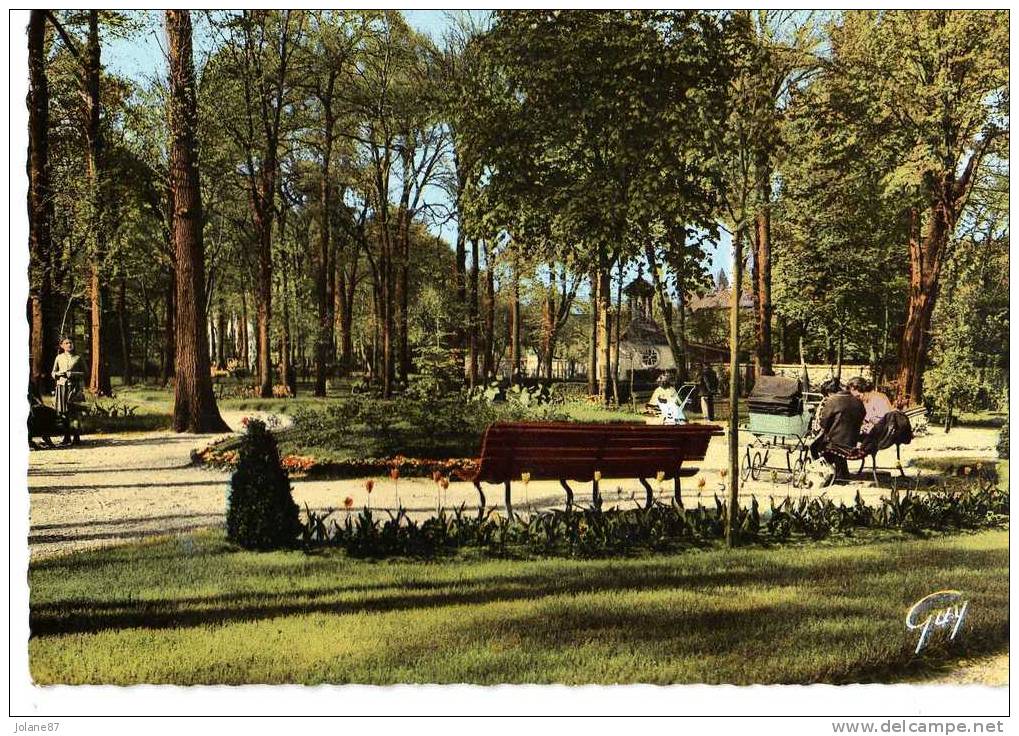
[226,420,302,549]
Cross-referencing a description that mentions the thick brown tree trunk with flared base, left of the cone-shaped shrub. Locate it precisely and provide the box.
[166,10,229,432]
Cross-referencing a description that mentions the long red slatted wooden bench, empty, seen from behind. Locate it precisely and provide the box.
[472,422,722,517]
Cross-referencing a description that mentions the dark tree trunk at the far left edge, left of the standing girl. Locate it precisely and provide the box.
[28,10,53,397]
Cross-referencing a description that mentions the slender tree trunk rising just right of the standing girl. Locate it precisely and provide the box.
[85,10,113,397]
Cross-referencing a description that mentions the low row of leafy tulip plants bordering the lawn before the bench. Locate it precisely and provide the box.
[303,467,1009,557]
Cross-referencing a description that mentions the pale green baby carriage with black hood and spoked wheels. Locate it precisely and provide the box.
[740,376,826,488]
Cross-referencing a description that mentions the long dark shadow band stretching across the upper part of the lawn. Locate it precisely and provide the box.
[30,532,1008,636]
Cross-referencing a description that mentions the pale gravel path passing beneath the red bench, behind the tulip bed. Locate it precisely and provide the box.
[29,412,997,559]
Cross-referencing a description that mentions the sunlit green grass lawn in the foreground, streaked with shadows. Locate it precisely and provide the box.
[29,530,1009,685]
